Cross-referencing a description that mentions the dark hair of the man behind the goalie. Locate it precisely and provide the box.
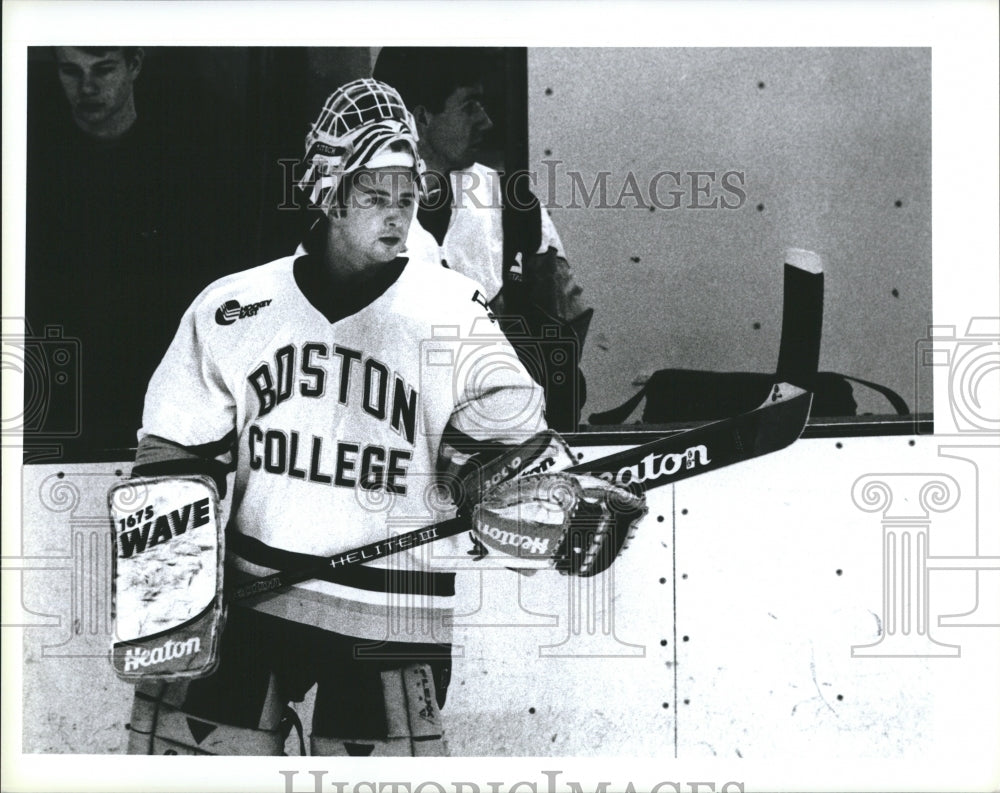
[372,47,499,113]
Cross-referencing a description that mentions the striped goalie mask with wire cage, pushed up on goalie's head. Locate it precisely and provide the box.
[298,78,424,213]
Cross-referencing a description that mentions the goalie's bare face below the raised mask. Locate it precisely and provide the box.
[328,168,417,271]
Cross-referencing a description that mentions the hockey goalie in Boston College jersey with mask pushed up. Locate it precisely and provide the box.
[109,79,645,756]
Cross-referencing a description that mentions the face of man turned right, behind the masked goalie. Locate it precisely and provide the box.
[420,85,493,172]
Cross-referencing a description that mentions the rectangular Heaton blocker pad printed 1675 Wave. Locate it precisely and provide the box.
[108,475,225,682]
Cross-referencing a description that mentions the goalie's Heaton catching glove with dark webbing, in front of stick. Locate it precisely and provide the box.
[472,473,648,577]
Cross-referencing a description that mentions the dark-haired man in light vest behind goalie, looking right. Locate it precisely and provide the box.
[374,47,593,431]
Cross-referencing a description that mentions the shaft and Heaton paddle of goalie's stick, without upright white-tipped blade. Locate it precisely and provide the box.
[229,383,812,602]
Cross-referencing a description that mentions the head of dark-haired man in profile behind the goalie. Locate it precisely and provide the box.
[374,47,493,174]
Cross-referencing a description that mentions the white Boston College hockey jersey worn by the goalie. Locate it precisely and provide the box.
[139,256,544,641]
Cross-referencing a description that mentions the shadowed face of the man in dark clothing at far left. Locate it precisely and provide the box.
[56,47,142,137]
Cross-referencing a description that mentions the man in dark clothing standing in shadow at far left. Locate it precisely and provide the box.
[24,46,235,460]
